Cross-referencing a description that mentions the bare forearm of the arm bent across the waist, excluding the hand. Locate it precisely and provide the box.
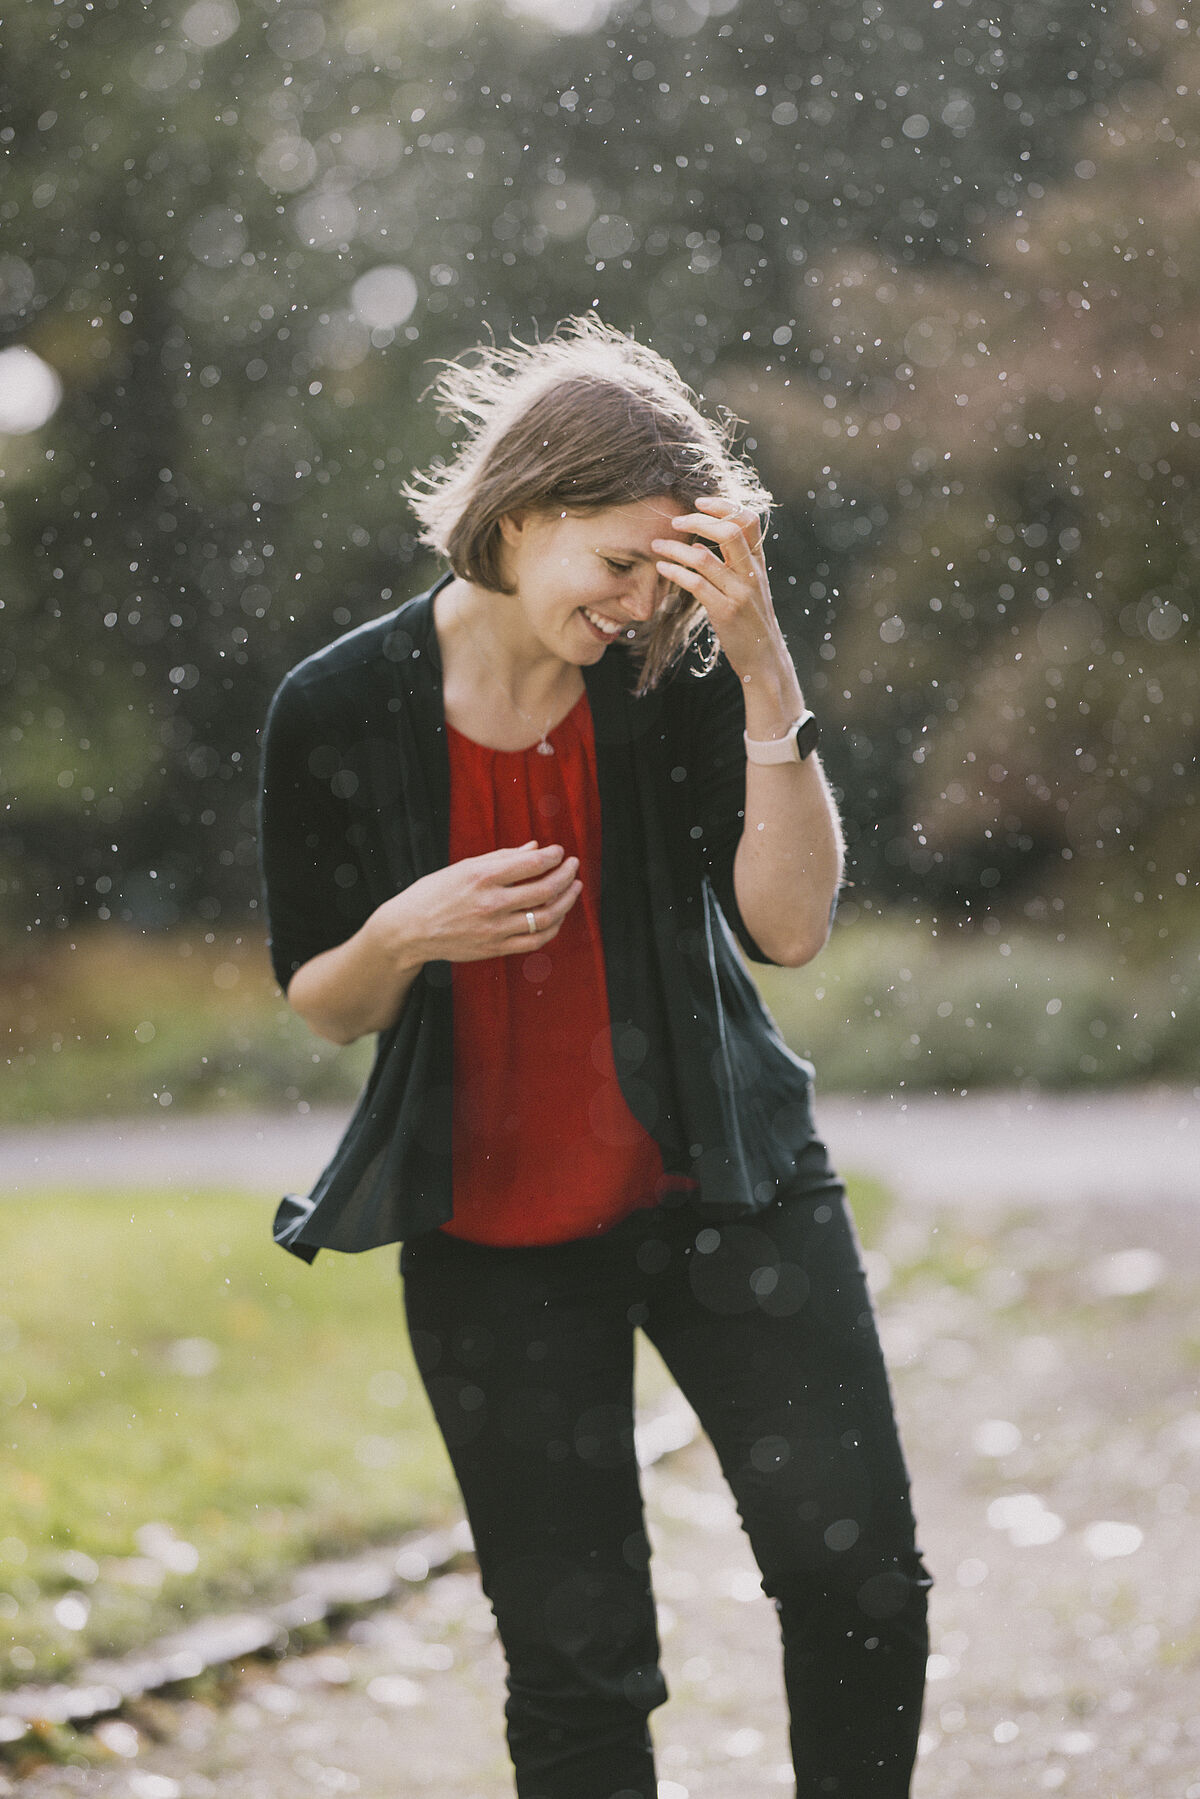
[288,901,423,1043]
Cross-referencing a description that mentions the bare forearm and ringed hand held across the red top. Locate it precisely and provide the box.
[288,844,581,1043]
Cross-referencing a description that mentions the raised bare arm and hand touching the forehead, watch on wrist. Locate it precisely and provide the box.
[655,498,842,966]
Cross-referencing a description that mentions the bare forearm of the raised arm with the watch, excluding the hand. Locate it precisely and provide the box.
[734,639,842,966]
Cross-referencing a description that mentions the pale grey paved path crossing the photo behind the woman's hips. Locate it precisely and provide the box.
[0,1088,1200,1205]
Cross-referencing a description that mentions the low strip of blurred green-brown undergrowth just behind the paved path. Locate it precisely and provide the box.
[0,913,1200,1124]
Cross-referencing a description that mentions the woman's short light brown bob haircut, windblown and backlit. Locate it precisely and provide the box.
[401,313,772,693]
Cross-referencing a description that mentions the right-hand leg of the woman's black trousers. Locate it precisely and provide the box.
[642,1144,928,1799]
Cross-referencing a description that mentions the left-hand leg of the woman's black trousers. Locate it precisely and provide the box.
[401,1238,666,1799]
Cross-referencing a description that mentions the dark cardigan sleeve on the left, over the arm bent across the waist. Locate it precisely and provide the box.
[259,675,371,989]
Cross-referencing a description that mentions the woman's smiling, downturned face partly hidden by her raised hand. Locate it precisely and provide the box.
[500,495,684,666]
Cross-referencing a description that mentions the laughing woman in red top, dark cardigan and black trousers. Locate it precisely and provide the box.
[263,318,928,1799]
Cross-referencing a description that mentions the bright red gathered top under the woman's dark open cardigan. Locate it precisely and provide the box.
[443,694,680,1245]
